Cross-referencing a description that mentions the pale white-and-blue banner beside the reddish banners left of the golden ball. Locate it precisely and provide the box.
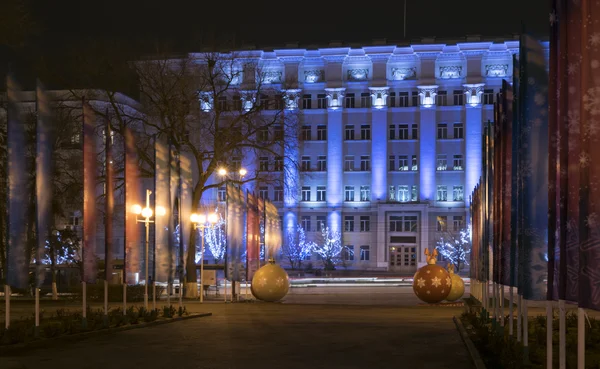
[225,183,245,282]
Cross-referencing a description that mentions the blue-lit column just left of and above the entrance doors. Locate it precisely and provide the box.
[369,87,389,202]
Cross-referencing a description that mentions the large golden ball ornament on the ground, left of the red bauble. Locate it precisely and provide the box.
[250,259,290,302]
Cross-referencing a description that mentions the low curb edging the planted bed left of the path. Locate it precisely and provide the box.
[0,313,212,355]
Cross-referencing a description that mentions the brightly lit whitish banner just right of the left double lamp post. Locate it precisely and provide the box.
[154,136,172,283]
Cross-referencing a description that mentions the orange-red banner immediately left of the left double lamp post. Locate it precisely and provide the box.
[123,127,142,284]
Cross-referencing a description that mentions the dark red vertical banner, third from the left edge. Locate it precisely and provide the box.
[82,99,98,283]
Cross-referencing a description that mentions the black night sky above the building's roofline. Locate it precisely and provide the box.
[31,0,549,51]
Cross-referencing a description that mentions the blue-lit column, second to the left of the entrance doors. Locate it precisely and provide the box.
[325,88,345,233]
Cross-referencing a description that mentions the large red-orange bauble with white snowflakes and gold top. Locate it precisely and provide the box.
[413,249,452,304]
